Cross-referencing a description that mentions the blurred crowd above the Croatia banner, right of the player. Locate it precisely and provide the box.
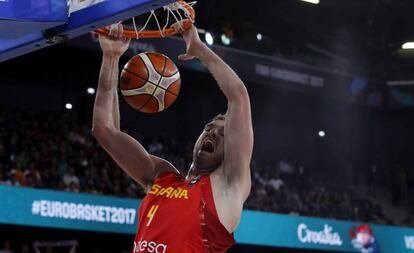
[246,161,393,224]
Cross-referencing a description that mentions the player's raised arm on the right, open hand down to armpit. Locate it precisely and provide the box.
[179,26,253,201]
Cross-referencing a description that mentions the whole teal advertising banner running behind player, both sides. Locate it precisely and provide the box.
[0,186,414,253]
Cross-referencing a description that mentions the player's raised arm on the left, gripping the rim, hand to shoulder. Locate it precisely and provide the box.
[92,24,174,188]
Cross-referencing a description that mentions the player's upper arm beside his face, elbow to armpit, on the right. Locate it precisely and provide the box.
[224,88,253,181]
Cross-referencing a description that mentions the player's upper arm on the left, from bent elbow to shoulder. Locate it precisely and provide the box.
[96,130,155,188]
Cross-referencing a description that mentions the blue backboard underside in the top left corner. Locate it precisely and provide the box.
[0,0,174,62]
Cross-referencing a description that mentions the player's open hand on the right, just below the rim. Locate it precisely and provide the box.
[172,23,205,60]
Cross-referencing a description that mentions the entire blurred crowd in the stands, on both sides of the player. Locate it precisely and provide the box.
[0,109,398,224]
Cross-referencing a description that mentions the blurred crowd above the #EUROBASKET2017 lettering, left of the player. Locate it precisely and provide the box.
[0,107,139,197]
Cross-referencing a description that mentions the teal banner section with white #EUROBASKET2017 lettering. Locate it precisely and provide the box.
[0,186,140,234]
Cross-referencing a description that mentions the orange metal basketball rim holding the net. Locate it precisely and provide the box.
[94,0,195,39]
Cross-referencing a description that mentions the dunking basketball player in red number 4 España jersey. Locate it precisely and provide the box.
[92,22,253,253]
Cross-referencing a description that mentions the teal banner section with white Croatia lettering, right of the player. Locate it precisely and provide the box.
[236,211,414,253]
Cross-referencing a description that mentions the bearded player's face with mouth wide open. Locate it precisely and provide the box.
[193,119,225,174]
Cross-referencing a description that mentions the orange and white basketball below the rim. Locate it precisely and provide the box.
[120,52,181,113]
